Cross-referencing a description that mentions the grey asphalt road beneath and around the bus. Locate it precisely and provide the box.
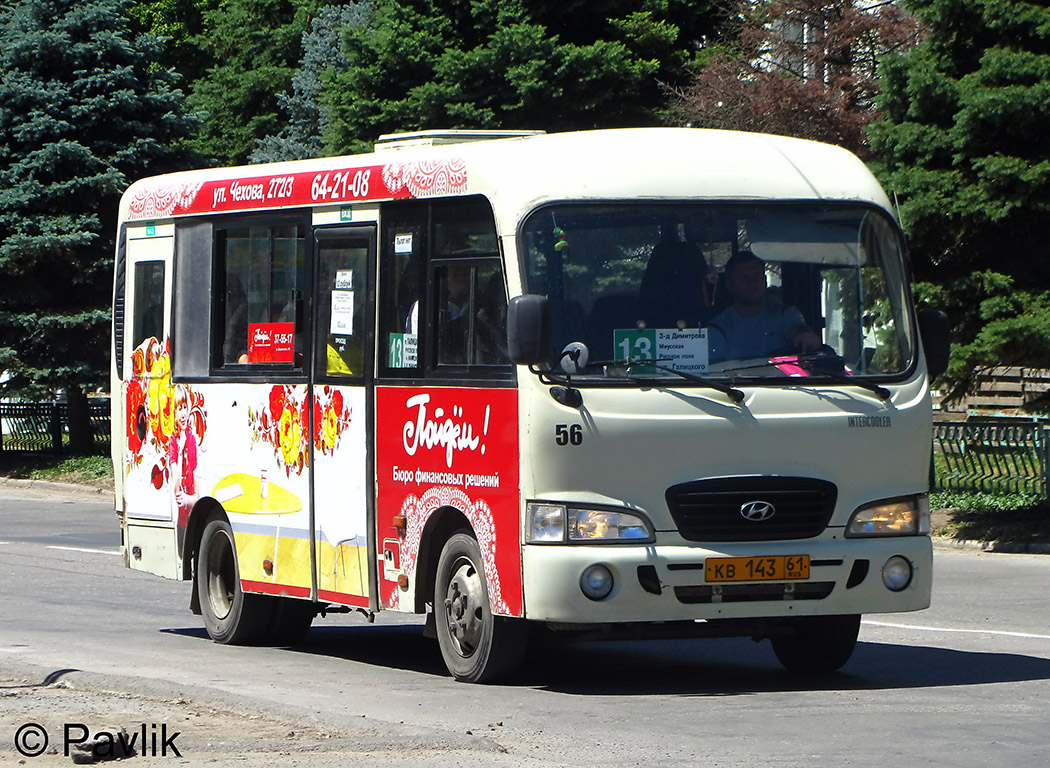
[0,486,1050,767]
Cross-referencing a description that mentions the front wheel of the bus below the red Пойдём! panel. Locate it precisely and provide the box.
[434,533,527,683]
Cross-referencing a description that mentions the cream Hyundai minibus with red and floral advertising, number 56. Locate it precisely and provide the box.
[111,128,947,682]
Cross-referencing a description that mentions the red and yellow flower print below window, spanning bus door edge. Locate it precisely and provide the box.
[248,385,353,477]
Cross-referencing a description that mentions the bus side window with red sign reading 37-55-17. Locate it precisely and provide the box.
[215,224,306,369]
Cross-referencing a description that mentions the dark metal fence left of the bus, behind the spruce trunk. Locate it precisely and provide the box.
[0,402,109,455]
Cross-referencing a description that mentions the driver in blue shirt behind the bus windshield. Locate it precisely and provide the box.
[708,251,821,362]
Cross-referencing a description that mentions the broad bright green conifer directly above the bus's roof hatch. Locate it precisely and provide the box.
[322,0,714,151]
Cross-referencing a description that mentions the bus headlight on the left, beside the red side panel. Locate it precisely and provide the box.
[525,502,653,544]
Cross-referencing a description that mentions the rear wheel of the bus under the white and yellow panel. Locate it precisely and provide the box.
[196,517,275,645]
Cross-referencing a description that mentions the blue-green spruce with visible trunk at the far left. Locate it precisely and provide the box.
[0,0,190,450]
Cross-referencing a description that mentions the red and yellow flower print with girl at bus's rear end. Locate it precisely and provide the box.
[125,338,208,493]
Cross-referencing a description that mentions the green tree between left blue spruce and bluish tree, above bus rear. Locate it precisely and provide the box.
[187,0,320,165]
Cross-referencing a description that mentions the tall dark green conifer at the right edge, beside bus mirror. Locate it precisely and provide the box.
[869,0,1050,403]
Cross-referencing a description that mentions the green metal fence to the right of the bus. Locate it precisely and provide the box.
[932,421,1050,499]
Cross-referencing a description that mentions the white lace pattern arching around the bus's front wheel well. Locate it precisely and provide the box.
[390,485,511,615]
